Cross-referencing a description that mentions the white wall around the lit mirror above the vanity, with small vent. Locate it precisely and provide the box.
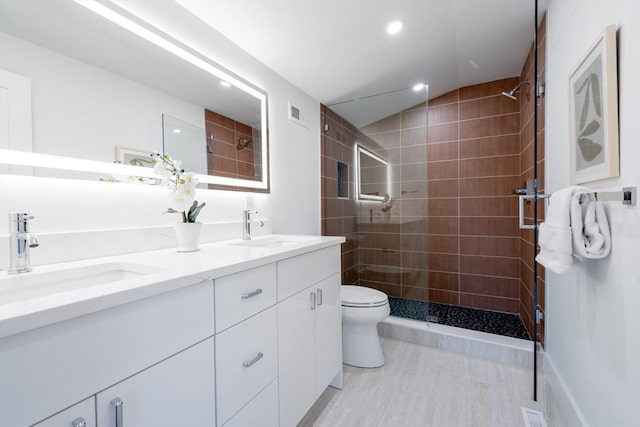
[0,1,320,264]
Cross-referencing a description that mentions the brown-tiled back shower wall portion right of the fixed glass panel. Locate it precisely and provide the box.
[427,77,521,313]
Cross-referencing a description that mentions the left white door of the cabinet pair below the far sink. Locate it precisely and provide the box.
[278,286,316,427]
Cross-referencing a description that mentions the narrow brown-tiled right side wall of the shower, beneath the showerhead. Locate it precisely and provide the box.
[519,15,547,342]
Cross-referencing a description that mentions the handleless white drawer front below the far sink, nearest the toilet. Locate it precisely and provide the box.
[278,245,340,301]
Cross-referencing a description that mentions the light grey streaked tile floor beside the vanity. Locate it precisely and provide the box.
[299,338,543,427]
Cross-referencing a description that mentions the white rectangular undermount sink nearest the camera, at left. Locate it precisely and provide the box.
[0,262,159,304]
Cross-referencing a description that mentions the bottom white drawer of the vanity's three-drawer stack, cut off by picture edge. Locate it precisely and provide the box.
[224,380,279,427]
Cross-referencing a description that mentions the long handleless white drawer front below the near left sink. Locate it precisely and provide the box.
[0,281,214,426]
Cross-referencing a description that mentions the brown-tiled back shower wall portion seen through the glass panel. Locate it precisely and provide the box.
[356,103,429,300]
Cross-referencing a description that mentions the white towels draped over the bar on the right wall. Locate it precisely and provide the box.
[536,186,611,274]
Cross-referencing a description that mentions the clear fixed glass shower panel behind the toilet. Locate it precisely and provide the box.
[322,88,429,321]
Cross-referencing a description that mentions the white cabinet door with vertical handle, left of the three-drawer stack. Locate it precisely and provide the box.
[97,338,216,427]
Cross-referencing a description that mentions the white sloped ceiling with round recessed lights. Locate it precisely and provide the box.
[176,0,550,104]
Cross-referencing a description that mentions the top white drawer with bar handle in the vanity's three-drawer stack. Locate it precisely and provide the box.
[215,264,276,333]
